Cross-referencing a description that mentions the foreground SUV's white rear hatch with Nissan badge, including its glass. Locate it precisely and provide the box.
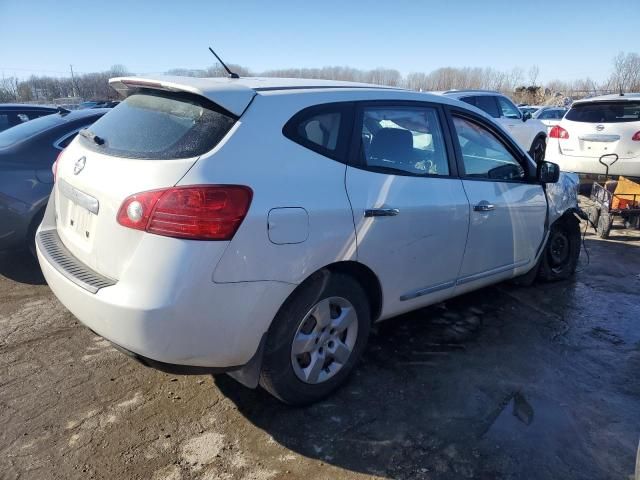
[55,83,246,280]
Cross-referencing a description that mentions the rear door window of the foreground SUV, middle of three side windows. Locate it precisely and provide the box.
[360,106,449,175]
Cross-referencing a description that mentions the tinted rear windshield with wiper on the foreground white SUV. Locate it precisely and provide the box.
[79,92,235,160]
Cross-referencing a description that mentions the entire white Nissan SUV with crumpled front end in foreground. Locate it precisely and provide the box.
[37,77,580,404]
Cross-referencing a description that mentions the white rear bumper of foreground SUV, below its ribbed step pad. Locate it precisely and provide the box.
[36,235,295,370]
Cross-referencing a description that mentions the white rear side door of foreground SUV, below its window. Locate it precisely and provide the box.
[346,167,469,318]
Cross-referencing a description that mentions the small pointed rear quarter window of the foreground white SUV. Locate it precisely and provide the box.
[282,103,352,161]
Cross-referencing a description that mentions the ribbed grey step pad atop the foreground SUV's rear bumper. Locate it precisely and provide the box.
[36,228,117,293]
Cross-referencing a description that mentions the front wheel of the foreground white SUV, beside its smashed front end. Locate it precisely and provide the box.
[538,216,580,282]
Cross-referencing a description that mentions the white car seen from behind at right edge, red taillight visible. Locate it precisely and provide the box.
[546,93,640,179]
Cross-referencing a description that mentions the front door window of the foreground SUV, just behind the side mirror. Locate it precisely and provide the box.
[453,116,526,181]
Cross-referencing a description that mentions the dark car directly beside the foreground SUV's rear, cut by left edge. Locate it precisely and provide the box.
[0,108,110,251]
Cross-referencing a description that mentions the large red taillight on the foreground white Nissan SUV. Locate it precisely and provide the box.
[117,185,253,240]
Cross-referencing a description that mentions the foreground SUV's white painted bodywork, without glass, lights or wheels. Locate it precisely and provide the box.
[33,77,576,368]
